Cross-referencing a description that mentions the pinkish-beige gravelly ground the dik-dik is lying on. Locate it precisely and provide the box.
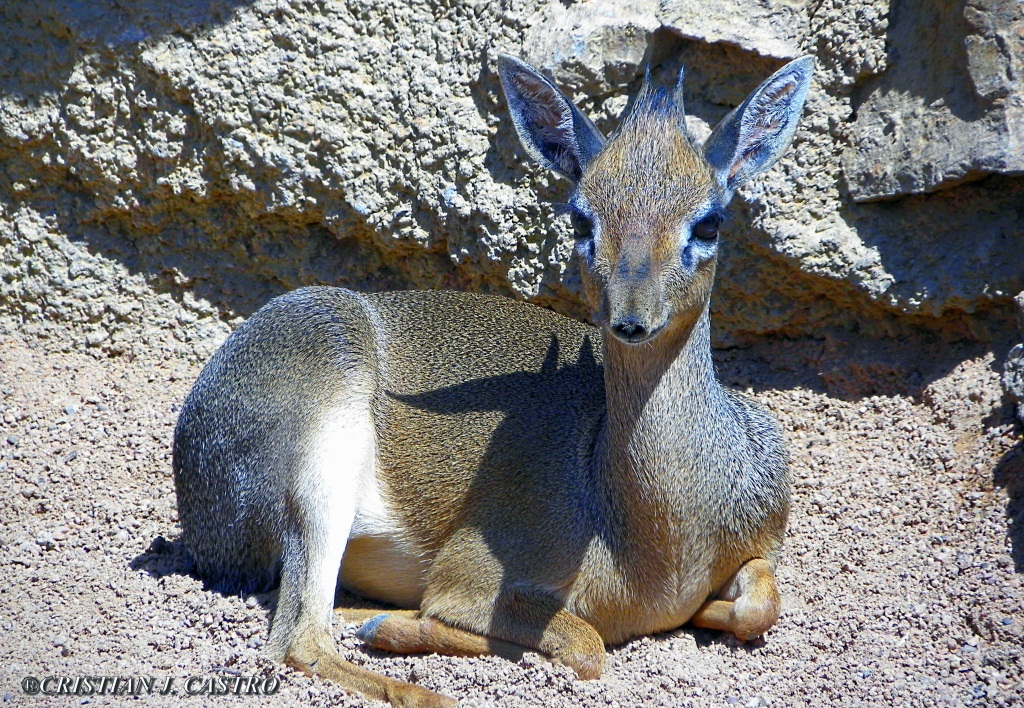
[0,327,1024,706]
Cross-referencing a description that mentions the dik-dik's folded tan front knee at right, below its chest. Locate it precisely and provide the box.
[690,558,781,641]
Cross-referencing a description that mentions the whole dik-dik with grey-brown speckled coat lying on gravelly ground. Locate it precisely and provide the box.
[174,56,813,705]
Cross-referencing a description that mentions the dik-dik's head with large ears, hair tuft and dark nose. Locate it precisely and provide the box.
[498,54,814,344]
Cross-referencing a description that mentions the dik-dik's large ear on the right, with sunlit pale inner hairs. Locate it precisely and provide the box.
[703,56,814,194]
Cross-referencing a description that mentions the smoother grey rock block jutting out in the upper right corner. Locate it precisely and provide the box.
[843,0,1024,202]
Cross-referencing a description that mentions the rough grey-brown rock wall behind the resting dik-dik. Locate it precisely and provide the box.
[0,0,1024,358]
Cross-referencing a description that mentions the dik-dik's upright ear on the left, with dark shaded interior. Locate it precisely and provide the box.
[498,54,604,182]
